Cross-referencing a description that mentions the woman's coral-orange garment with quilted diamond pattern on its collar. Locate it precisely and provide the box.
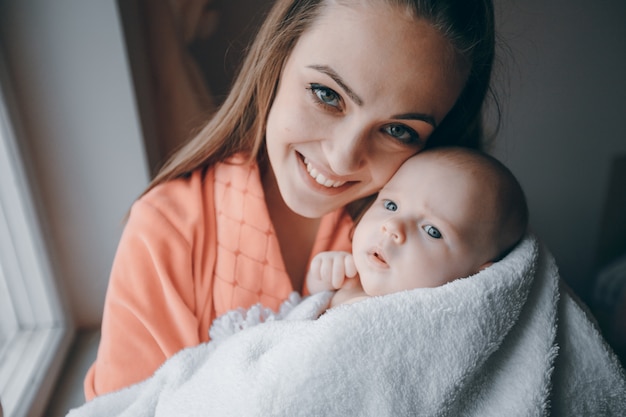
[84,157,352,400]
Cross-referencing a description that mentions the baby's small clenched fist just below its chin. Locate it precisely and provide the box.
[307,251,357,294]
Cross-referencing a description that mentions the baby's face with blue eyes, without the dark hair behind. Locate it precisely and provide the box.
[352,155,498,296]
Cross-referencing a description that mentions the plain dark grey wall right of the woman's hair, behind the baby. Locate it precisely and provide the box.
[496,0,626,297]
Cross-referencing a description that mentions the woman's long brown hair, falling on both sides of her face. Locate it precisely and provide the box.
[144,0,495,197]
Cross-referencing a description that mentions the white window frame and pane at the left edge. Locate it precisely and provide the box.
[0,56,72,417]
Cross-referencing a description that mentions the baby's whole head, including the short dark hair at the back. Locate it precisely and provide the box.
[352,148,528,295]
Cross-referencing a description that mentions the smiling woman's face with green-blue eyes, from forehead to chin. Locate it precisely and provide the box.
[266,5,466,218]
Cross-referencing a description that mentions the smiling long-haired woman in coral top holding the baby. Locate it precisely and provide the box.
[85,0,494,399]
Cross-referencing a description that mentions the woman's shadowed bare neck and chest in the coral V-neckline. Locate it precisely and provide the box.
[262,168,320,292]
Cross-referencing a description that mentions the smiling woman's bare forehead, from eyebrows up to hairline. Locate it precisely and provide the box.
[289,2,466,122]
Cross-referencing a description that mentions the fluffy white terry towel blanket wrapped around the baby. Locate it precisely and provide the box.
[69,235,626,417]
